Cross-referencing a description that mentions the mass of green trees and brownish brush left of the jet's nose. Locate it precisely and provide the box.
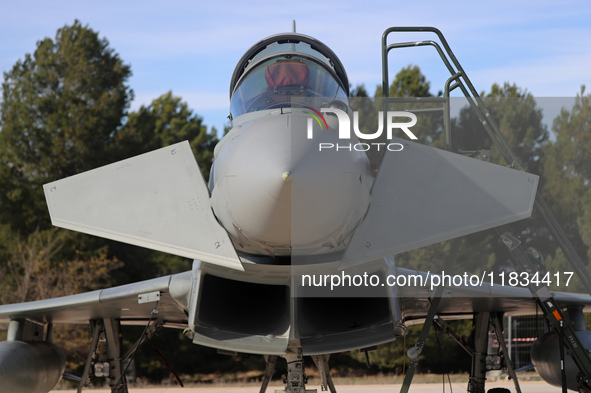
[0,21,224,380]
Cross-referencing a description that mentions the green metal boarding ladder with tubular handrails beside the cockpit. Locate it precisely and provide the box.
[382,27,591,392]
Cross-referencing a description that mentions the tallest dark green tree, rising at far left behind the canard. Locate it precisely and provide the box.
[0,21,133,233]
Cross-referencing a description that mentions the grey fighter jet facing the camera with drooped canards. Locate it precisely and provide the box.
[0,27,591,393]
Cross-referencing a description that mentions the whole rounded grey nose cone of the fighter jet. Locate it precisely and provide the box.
[212,112,370,255]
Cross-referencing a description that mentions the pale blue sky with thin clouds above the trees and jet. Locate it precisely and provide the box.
[0,0,591,130]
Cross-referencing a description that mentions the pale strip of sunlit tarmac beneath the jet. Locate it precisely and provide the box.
[54,381,562,393]
